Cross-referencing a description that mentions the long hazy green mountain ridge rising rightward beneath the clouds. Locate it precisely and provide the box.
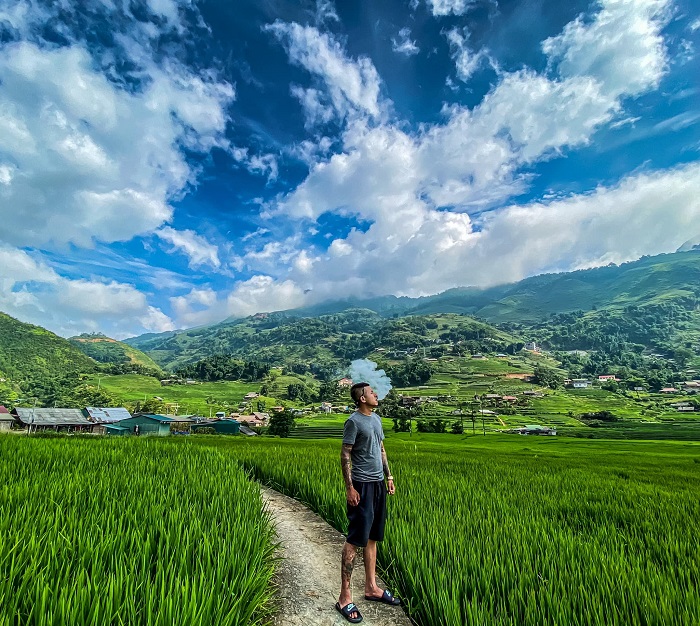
[126,250,700,369]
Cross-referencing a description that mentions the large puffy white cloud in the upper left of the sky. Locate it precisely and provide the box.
[0,36,233,246]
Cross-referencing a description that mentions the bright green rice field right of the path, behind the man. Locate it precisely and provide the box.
[211,437,700,626]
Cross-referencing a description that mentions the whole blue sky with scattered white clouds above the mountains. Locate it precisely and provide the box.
[0,0,700,338]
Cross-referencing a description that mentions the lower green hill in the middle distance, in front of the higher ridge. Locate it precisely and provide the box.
[127,309,519,374]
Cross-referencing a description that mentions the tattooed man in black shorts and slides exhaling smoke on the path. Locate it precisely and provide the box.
[335,383,401,624]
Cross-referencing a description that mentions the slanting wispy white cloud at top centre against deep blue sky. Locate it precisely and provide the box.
[266,20,381,119]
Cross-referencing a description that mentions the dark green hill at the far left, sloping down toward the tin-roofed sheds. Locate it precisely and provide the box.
[0,313,96,385]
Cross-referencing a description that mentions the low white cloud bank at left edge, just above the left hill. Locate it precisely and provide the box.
[0,243,174,338]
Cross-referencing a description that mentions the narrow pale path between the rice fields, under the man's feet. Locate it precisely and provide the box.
[263,488,411,626]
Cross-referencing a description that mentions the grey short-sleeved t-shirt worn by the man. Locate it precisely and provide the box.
[343,411,384,483]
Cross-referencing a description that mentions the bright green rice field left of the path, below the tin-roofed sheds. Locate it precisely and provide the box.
[0,436,275,626]
